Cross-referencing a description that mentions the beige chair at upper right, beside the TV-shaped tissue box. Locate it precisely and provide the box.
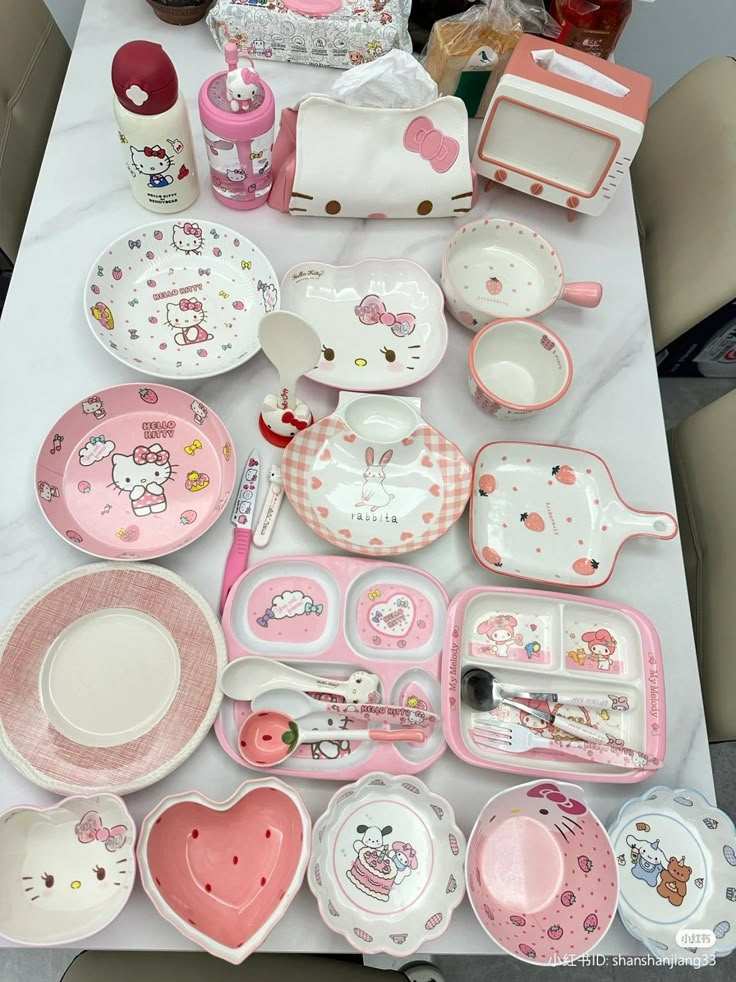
[631,58,736,351]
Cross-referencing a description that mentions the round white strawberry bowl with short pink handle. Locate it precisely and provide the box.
[440,218,603,331]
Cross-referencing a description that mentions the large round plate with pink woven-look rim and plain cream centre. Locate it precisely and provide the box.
[0,563,225,800]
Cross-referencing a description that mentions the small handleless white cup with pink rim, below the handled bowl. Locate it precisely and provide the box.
[468,320,572,419]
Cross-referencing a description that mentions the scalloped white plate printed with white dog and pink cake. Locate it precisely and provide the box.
[308,773,465,956]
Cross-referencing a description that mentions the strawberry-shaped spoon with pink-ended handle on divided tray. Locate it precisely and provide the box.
[238,710,427,767]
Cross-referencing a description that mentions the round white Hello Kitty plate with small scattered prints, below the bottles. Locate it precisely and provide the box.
[84,217,279,378]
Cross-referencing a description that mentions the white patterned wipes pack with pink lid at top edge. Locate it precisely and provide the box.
[207,0,412,68]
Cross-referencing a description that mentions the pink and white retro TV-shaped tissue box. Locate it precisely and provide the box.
[473,34,652,215]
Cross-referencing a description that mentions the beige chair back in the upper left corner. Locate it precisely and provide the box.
[0,0,69,265]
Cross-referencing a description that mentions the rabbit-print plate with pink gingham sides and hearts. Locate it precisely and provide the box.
[281,392,470,556]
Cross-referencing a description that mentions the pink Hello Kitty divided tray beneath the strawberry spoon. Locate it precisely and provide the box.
[215,556,448,781]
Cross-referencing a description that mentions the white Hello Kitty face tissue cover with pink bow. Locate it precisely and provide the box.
[268,95,477,218]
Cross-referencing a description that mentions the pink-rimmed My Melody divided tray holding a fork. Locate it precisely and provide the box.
[442,587,667,783]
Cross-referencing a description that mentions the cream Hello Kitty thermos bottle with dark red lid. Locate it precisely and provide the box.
[112,41,199,214]
